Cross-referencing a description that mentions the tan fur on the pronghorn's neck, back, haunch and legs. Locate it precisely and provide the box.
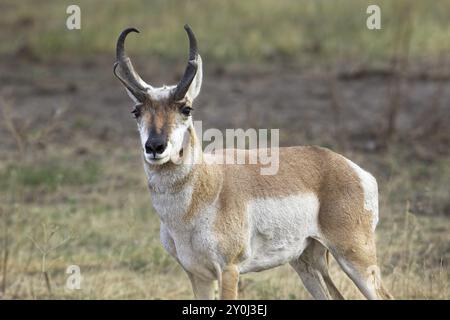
[143,123,391,299]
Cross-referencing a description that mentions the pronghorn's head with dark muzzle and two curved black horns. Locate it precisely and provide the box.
[114,25,202,165]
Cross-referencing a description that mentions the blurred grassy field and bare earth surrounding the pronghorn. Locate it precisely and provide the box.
[0,0,450,299]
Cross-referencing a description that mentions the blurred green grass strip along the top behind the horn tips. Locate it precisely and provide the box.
[5,0,450,65]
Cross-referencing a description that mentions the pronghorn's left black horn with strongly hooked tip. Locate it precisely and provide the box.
[113,28,146,101]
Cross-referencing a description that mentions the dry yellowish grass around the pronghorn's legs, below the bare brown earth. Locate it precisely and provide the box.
[0,138,450,299]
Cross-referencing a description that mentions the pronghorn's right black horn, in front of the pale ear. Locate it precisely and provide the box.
[174,24,198,101]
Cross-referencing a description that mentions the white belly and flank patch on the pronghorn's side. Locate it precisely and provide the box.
[239,193,319,273]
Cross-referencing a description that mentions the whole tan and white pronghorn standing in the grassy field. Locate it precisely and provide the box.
[114,25,391,299]
